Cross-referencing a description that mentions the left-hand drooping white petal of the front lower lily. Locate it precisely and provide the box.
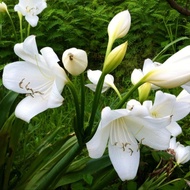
[86,122,110,158]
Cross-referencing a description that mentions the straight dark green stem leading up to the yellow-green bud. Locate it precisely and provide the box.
[85,73,106,140]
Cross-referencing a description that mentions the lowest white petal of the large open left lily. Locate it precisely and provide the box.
[15,95,47,123]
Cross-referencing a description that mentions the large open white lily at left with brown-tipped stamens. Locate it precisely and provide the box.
[3,35,68,122]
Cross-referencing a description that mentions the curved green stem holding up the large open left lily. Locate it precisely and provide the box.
[67,81,84,145]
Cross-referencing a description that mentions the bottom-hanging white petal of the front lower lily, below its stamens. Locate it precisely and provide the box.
[108,140,140,181]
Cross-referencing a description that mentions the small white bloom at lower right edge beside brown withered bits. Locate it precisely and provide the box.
[168,137,190,164]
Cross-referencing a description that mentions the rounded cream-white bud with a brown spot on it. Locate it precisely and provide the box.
[62,48,88,76]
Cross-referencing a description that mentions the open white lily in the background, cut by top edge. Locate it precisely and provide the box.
[14,0,47,27]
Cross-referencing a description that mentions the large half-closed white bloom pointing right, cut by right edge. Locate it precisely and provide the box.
[141,46,190,88]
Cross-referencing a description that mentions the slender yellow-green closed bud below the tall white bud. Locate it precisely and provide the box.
[103,42,128,74]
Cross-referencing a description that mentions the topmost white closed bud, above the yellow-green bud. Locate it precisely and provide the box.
[108,10,131,41]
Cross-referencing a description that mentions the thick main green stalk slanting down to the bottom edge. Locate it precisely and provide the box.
[36,143,83,190]
